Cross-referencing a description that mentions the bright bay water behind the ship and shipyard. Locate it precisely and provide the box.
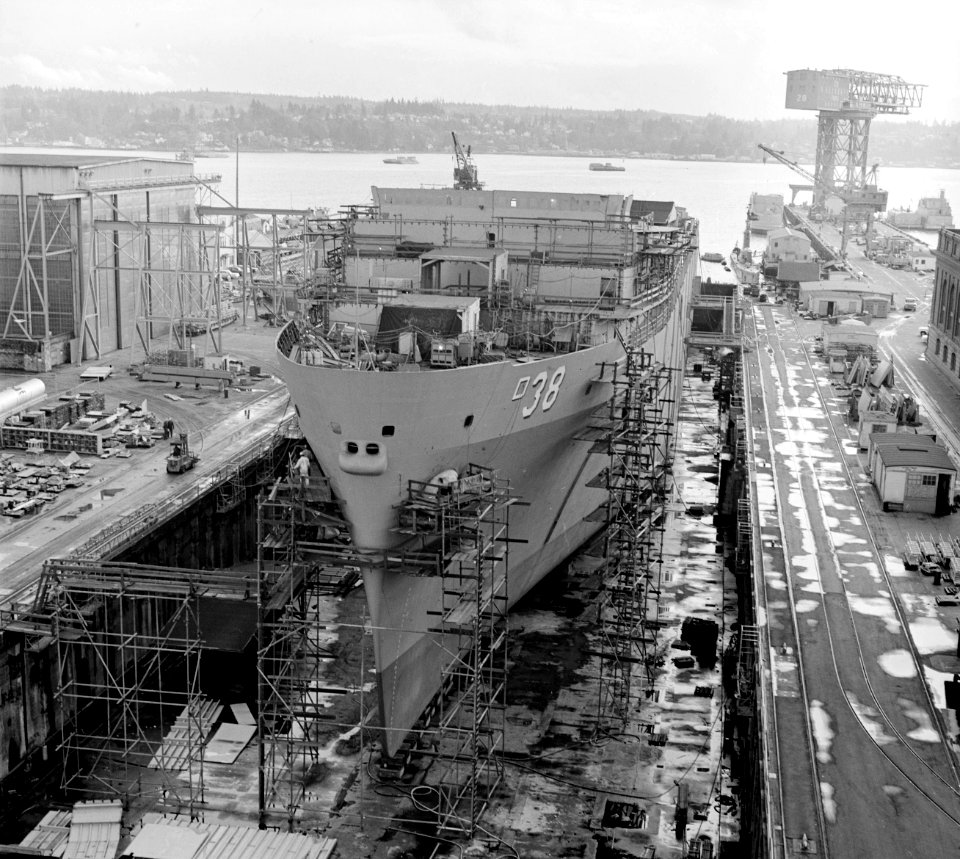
[7,149,960,253]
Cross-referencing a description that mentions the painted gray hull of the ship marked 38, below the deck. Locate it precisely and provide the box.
[280,293,688,755]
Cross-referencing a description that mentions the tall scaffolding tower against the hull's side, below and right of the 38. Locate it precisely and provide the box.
[592,351,676,727]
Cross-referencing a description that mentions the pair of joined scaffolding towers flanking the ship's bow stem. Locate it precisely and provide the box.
[257,466,516,834]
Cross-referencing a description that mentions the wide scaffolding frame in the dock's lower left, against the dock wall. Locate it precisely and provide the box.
[34,559,245,818]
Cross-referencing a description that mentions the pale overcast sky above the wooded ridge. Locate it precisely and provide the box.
[0,0,960,122]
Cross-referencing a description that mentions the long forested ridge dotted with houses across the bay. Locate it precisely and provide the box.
[0,86,960,167]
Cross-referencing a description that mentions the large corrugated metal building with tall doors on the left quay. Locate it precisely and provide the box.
[0,154,209,372]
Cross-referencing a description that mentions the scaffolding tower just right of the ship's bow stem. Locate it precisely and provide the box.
[399,465,517,836]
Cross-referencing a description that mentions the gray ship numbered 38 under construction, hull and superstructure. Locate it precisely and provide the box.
[276,137,698,756]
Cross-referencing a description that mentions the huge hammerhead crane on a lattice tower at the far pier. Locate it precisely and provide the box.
[786,69,925,211]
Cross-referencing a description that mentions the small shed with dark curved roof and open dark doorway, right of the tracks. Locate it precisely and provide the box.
[870,433,956,516]
